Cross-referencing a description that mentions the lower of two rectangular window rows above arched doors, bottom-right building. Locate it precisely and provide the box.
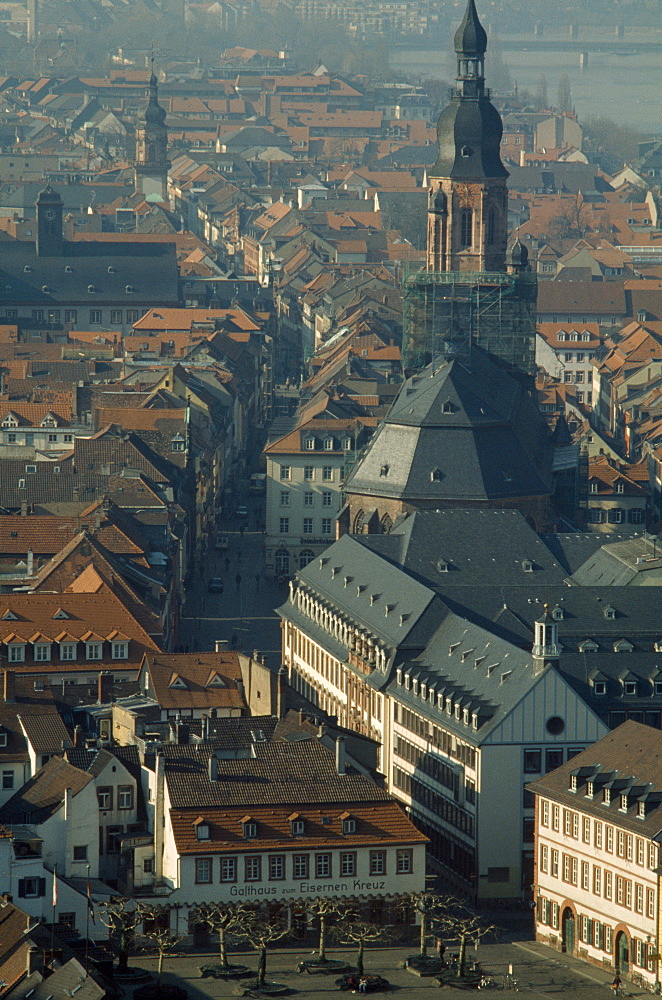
[540,844,655,919]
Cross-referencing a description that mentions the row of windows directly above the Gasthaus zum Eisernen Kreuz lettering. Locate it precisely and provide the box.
[195,848,414,884]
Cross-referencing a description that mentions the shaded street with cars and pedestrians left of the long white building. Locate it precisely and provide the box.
[180,512,287,670]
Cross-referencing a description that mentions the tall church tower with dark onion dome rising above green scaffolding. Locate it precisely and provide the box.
[427,0,508,273]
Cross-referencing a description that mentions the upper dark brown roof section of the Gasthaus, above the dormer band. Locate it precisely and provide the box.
[163,736,396,809]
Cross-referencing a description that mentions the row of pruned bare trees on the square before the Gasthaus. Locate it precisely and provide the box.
[101,890,495,984]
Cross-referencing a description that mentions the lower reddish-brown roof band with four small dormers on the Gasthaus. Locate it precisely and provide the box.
[170,796,427,854]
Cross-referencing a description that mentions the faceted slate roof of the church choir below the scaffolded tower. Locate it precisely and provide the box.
[345,348,553,501]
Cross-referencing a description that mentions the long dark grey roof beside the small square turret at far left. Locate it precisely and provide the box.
[0,240,178,309]
